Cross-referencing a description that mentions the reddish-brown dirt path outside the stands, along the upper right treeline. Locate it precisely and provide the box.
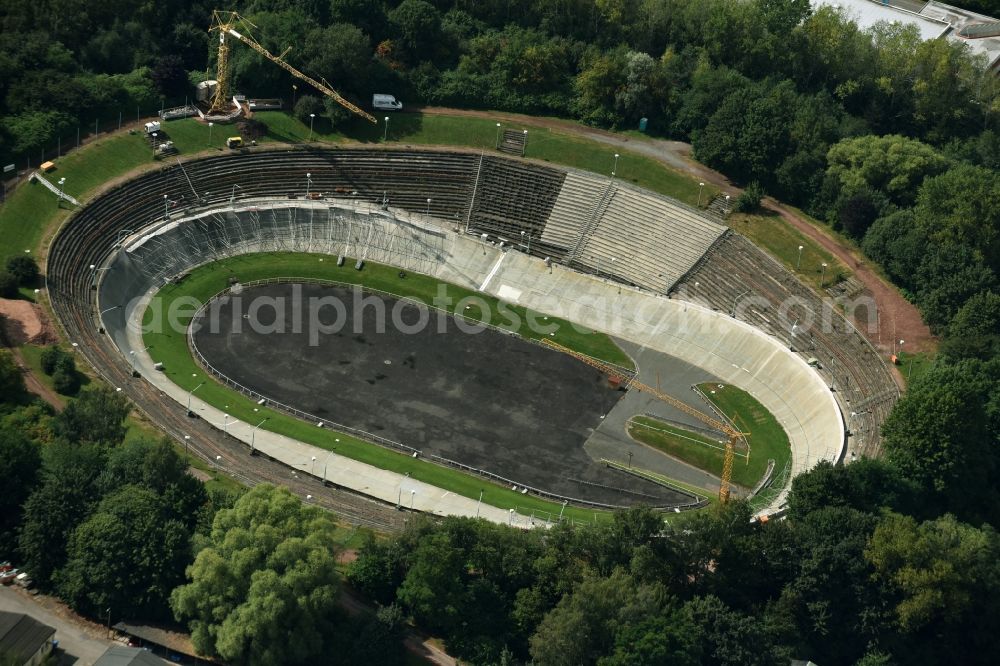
[417,106,936,352]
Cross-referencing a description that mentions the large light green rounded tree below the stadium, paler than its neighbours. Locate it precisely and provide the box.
[170,484,338,666]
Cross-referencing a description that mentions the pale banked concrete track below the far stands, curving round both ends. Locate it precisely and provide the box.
[95,199,845,524]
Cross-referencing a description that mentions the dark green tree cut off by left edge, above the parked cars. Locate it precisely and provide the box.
[0,426,42,558]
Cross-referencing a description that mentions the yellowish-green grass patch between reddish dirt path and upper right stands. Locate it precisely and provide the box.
[727,213,853,289]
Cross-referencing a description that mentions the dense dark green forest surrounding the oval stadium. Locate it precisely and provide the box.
[0,0,1000,666]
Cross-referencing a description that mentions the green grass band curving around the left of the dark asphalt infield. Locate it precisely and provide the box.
[144,253,631,520]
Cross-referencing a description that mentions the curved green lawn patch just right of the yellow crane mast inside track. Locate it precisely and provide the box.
[698,382,792,488]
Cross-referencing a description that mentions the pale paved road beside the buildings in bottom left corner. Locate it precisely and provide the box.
[0,586,115,666]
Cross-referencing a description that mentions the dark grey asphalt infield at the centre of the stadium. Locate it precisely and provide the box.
[194,284,687,506]
